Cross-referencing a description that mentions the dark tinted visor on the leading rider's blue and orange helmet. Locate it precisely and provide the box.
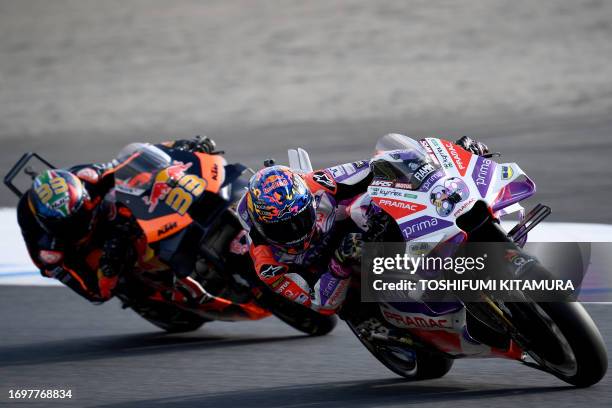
[259,204,316,246]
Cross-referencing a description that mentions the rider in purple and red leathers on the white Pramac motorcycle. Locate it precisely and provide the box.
[237,137,488,314]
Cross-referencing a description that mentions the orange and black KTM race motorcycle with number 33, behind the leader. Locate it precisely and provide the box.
[5,143,336,335]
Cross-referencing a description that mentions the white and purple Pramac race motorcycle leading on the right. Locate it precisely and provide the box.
[290,134,608,387]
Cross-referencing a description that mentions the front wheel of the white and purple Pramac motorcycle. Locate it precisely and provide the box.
[506,302,608,387]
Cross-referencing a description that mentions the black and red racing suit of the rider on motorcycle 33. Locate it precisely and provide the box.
[17,136,215,302]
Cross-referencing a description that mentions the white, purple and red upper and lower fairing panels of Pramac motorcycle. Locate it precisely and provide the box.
[366,134,526,356]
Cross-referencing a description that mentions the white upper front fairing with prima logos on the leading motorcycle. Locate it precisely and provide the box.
[368,134,526,242]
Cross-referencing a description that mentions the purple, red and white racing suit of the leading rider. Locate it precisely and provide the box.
[237,161,372,314]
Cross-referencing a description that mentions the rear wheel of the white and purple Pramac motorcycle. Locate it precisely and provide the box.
[347,321,453,381]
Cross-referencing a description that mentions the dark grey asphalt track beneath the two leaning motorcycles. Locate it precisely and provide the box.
[0,286,612,408]
